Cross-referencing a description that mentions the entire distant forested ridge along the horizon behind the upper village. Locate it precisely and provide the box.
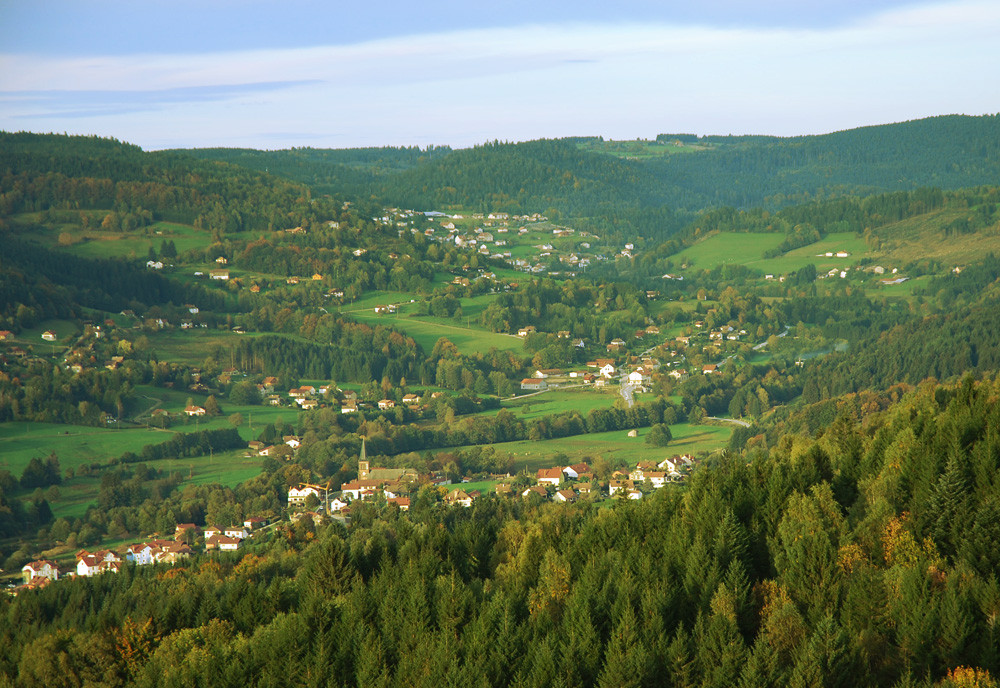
[174,115,1000,237]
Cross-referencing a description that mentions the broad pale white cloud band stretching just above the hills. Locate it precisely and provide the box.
[0,0,1000,147]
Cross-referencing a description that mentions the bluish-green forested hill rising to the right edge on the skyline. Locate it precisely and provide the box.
[646,115,1000,207]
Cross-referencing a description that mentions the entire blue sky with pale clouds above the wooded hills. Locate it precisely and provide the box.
[0,0,1000,150]
